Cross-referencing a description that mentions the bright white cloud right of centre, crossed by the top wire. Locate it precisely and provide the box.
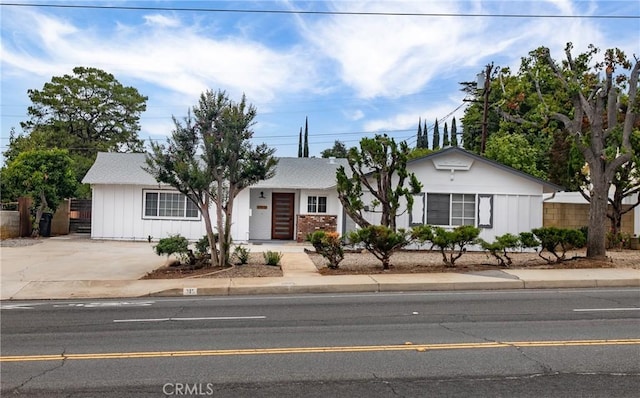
[304,2,501,98]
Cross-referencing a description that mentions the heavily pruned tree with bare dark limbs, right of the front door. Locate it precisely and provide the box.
[336,134,422,231]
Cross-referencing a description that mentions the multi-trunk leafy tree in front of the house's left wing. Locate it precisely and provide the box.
[146,90,277,266]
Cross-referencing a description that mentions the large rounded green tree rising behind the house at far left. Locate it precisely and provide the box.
[5,67,147,194]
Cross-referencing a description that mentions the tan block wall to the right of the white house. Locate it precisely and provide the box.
[542,203,633,235]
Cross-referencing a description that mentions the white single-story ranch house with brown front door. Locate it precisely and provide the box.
[83,148,561,242]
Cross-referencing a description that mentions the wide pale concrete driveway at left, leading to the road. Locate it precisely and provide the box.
[0,235,166,300]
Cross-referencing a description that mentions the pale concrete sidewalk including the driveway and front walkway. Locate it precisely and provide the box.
[0,236,640,300]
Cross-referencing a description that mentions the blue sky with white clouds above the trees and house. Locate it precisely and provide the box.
[0,0,640,160]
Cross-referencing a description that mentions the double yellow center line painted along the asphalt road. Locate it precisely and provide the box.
[0,339,640,362]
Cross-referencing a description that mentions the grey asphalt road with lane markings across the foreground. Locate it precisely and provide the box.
[0,289,640,397]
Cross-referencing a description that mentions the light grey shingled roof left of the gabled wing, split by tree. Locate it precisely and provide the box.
[82,152,348,189]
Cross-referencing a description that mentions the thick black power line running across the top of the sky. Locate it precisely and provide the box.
[0,3,640,19]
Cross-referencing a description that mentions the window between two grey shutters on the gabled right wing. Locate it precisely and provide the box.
[427,193,476,226]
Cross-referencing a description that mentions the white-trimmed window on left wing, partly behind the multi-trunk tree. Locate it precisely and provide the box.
[143,191,200,219]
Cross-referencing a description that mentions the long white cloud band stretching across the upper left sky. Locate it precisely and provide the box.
[2,7,315,107]
